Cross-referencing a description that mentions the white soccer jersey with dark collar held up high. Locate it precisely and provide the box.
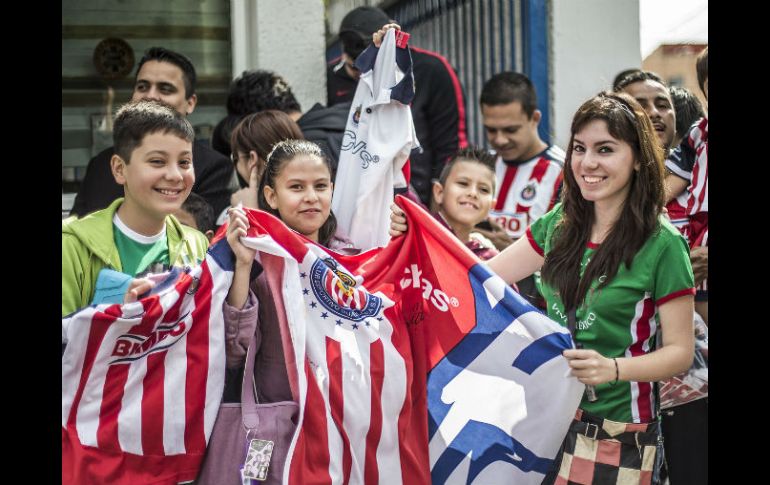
[332,29,419,250]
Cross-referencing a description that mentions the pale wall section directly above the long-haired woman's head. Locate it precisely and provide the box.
[551,0,642,149]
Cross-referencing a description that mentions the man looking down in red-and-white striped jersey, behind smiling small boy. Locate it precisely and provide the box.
[479,71,564,308]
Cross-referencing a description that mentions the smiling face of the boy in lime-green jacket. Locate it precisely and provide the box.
[112,132,195,233]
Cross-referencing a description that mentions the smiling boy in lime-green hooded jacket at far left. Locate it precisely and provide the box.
[61,101,208,316]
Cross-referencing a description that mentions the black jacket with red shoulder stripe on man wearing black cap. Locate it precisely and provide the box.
[326,47,467,205]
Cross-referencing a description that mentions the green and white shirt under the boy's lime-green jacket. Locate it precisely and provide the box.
[112,213,170,276]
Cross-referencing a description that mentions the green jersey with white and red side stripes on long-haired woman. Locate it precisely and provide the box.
[527,203,695,423]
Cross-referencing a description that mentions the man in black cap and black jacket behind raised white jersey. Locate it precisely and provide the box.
[326,7,468,205]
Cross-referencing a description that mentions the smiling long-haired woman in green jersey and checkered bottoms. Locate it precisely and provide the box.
[391,93,695,484]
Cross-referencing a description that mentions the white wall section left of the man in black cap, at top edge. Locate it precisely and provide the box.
[230,0,326,111]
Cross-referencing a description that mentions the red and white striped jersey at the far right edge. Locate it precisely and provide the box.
[666,118,709,215]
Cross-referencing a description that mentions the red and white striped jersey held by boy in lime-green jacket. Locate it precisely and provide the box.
[62,246,232,484]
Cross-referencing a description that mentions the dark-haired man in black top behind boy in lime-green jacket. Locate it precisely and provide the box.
[71,47,233,217]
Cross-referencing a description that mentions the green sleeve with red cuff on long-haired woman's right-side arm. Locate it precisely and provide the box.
[653,230,695,306]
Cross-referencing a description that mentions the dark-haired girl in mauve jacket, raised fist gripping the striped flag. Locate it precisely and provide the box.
[203,139,358,484]
